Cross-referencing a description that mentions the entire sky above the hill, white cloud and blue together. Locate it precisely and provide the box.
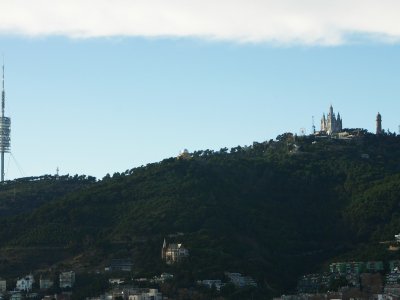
[0,0,400,179]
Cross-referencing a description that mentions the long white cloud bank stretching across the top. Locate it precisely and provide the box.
[0,0,400,45]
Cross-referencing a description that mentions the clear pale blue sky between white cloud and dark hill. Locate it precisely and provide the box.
[0,0,400,179]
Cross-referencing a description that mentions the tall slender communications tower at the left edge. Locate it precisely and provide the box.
[0,63,11,182]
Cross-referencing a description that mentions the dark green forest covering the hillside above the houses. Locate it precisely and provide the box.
[0,132,400,295]
